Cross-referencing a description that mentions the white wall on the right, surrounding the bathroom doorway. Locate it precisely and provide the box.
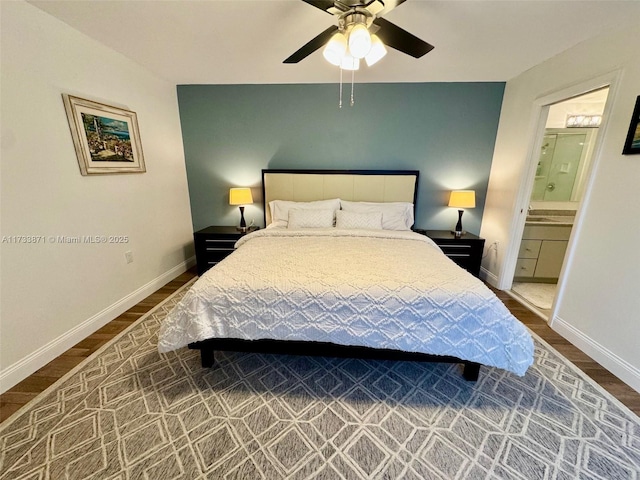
[481,24,640,391]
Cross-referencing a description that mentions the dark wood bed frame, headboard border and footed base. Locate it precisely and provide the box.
[189,169,480,381]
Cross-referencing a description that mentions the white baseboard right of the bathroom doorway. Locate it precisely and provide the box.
[551,316,640,393]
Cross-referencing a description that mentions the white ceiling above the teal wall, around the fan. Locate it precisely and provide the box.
[29,0,640,84]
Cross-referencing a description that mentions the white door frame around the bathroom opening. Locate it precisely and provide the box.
[499,69,622,326]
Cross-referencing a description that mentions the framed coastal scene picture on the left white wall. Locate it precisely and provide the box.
[62,94,146,175]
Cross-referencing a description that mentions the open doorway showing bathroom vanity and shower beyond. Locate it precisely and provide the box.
[511,86,609,321]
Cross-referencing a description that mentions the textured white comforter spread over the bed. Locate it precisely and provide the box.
[158,228,533,375]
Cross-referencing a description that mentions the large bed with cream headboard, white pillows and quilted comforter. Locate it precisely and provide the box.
[158,170,533,380]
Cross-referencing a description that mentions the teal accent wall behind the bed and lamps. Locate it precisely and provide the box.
[178,82,504,234]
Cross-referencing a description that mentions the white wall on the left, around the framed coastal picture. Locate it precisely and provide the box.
[0,1,193,391]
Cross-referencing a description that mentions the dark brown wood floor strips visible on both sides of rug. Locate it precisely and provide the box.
[0,268,640,422]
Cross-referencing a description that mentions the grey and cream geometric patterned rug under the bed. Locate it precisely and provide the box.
[0,285,640,480]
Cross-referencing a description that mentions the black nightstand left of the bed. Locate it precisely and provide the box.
[193,226,258,275]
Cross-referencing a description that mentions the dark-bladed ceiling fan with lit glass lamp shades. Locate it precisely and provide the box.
[283,0,434,70]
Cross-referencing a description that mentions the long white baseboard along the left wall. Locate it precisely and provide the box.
[0,257,195,393]
